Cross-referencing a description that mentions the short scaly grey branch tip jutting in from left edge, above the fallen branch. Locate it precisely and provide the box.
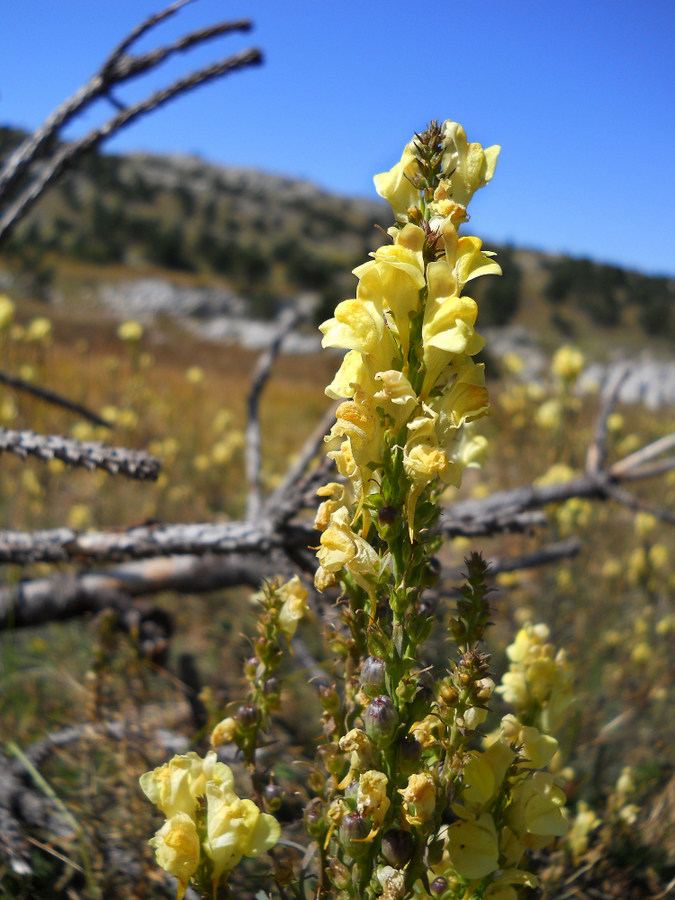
[0,428,160,481]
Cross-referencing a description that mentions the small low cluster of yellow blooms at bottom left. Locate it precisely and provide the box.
[140,751,281,900]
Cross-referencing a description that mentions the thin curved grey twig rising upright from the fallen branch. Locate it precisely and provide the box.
[245,306,302,522]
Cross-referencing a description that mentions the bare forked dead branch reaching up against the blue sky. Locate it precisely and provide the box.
[0,0,262,245]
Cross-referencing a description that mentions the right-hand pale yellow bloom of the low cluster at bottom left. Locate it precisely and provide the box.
[204,782,281,884]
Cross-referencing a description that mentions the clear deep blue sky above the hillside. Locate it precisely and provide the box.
[0,0,675,275]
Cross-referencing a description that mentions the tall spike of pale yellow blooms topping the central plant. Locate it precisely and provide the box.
[316,116,500,600]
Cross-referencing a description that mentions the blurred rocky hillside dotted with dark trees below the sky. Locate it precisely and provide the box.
[0,128,675,359]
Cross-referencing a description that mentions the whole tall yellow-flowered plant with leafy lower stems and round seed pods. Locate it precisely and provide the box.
[308,122,569,900]
